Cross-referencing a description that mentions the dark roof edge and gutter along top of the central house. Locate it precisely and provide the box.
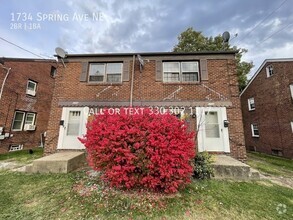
[66,50,238,58]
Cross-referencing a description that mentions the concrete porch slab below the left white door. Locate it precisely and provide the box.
[26,151,86,173]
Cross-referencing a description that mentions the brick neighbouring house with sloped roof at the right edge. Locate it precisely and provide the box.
[241,59,293,159]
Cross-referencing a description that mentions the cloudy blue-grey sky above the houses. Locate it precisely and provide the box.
[0,0,293,77]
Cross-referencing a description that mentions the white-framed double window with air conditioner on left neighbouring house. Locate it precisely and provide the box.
[11,111,36,131]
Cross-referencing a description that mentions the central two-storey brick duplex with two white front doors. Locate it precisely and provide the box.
[45,51,246,160]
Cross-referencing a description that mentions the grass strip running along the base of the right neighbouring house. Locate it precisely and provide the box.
[247,152,293,177]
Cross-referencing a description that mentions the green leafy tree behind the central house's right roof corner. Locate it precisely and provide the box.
[173,27,253,91]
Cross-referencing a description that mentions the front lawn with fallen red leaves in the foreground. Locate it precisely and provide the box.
[0,170,293,220]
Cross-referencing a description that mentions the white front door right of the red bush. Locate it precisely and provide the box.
[196,107,230,152]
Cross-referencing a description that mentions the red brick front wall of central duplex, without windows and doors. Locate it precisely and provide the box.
[45,52,246,159]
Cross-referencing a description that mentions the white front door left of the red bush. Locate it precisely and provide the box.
[58,108,88,149]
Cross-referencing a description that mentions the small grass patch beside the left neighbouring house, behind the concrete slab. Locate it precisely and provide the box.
[0,147,43,164]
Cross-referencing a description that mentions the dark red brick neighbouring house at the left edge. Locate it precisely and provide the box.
[0,58,57,153]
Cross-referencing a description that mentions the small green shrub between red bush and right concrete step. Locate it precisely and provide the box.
[193,151,214,179]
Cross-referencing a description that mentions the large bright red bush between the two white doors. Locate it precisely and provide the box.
[80,108,195,193]
